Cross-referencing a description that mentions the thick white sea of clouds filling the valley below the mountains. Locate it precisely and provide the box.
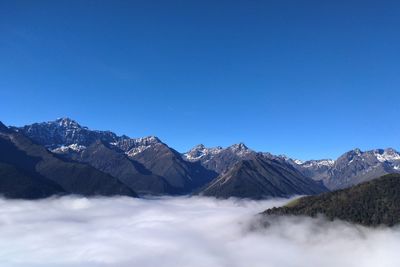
[0,197,400,267]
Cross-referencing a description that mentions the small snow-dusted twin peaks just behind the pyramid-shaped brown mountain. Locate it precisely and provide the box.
[183,143,257,174]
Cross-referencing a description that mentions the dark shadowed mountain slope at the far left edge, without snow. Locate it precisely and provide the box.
[0,121,136,198]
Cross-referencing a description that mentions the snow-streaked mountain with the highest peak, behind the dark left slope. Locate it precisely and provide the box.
[16,118,217,194]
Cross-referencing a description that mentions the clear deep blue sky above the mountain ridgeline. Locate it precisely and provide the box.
[0,0,400,159]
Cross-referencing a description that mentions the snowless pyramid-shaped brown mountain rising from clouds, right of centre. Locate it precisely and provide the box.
[201,154,327,199]
